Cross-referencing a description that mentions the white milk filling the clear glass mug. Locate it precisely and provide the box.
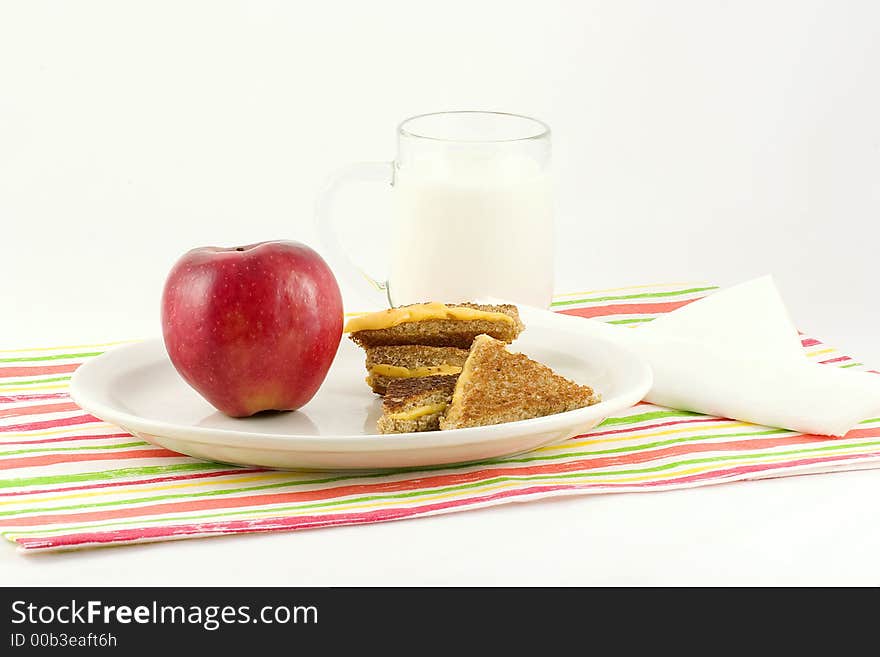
[389,156,553,307]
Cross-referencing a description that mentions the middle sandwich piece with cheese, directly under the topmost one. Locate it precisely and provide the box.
[365,344,468,395]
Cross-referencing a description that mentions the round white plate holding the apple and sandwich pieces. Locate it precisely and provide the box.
[70,308,651,470]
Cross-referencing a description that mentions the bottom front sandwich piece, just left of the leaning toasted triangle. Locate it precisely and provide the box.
[376,375,457,433]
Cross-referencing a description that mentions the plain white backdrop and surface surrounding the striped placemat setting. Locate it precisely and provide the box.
[0,0,880,584]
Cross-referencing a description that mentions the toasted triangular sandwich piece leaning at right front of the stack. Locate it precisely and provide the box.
[440,335,600,430]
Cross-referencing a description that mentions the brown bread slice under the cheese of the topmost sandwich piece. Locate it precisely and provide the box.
[351,303,524,349]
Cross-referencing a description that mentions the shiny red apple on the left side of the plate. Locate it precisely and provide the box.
[162,242,343,417]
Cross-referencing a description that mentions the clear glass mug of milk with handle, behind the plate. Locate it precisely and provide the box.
[316,111,554,308]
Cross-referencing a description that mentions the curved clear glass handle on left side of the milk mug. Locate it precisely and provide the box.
[315,162,394,306]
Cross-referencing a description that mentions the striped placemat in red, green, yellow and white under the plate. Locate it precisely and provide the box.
[0,284,880,552]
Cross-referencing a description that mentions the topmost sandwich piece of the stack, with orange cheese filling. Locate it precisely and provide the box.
[344,302,524,349]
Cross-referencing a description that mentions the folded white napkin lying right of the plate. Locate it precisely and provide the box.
[552,276,880,436]
